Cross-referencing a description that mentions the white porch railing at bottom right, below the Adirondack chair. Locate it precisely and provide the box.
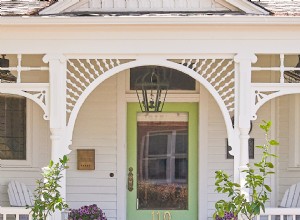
[256,208,300,220]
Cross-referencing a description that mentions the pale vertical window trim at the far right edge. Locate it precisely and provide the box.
[288,94,300,170]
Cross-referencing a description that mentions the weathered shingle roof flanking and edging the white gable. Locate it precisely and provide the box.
[0,0,300,16]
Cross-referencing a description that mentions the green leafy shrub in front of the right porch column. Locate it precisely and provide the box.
[214,121,279,220]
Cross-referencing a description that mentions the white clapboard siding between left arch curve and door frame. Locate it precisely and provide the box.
[67,77,117,220]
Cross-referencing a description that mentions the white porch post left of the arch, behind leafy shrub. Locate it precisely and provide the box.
[43,54,70,220]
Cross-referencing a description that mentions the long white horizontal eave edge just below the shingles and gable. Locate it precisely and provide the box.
[0,15,300,26]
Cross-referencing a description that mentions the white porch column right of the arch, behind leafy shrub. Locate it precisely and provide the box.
[234,53,257,198]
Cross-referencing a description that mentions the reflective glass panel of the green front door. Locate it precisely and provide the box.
[137,113,188,210]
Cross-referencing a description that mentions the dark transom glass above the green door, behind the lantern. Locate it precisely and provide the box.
[130,66,196,91]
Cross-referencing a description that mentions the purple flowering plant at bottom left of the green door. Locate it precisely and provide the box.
[69,204,107,220]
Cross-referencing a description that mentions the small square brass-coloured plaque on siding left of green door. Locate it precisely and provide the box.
[77,149,95,170]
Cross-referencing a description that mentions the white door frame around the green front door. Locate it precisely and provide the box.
[117,70,209,220]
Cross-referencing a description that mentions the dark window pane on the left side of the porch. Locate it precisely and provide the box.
[0,94,26,160]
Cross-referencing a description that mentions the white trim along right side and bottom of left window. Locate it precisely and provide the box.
[0,99,33,168]
